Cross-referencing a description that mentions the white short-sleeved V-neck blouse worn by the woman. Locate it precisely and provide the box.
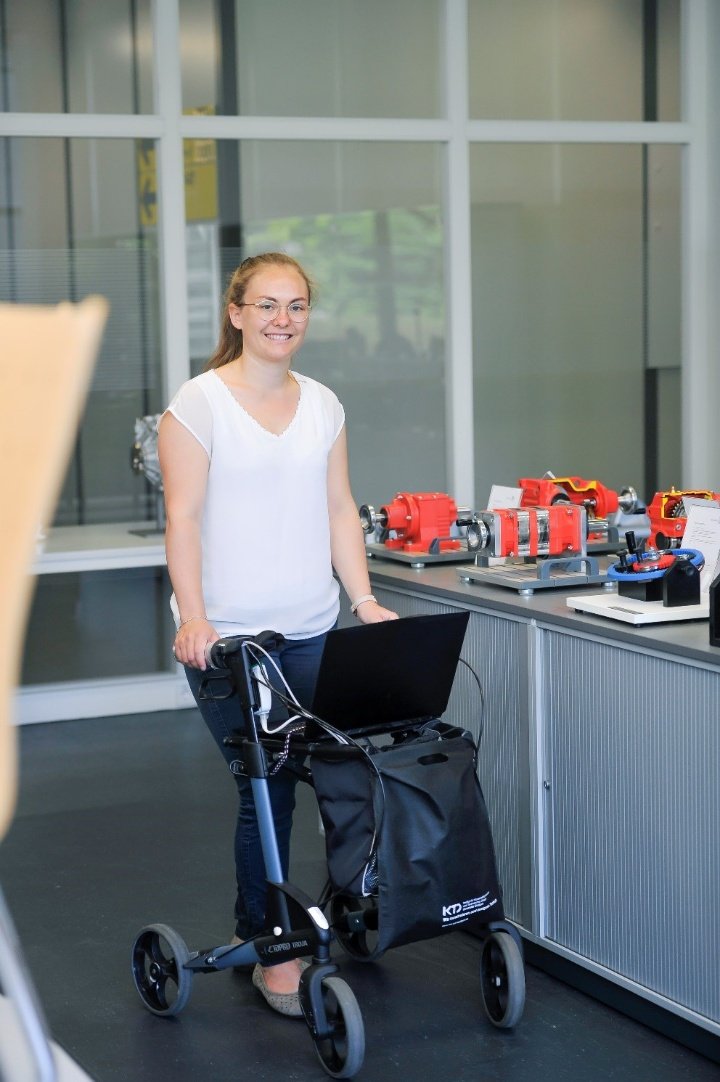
[168,370,345,638]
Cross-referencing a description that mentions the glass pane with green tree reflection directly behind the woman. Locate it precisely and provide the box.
[185,140,448,503]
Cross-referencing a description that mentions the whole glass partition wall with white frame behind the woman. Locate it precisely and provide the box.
[0,0,697,709]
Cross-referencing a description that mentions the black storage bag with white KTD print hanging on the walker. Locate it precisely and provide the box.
[311,723,503,952]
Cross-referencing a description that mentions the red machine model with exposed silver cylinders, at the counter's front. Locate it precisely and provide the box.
[468,503,586,558]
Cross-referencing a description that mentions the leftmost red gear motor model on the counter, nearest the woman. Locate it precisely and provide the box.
[359,492,467,553]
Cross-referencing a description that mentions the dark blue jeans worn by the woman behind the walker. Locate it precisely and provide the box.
[185,635,325,939]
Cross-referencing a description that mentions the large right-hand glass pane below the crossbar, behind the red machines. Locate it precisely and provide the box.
[470,144,681,500]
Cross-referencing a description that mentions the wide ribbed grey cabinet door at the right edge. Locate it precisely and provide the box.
[540,631,720,1020]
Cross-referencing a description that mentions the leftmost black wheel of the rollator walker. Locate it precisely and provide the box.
[132,924,193,1017]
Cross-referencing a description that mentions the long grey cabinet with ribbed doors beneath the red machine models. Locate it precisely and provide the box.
[371,564,720,1034]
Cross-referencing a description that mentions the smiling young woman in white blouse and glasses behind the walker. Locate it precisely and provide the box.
[158,252,396,1015]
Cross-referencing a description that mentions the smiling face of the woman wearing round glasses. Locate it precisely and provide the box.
[228,266,309,362]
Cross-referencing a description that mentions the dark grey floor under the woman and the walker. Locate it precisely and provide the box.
[0,711,720,1082]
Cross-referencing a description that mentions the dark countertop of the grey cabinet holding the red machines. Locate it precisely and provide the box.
[368,556,720,668]
